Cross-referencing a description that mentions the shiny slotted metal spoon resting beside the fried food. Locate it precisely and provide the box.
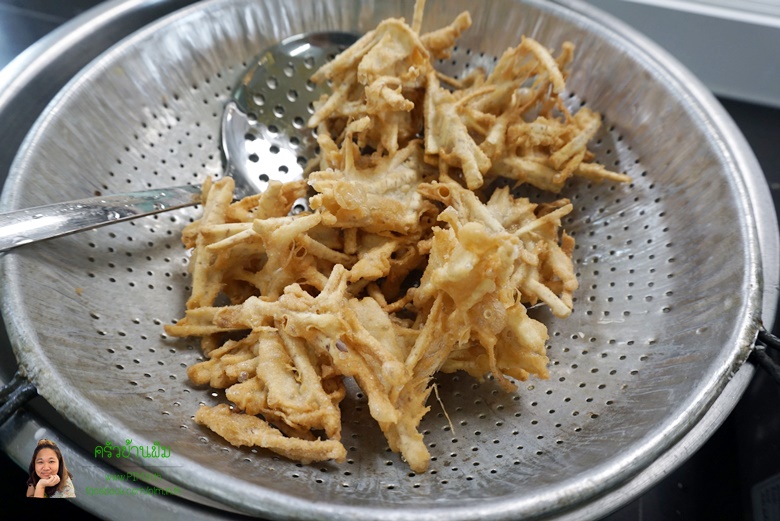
[0,31,357,252]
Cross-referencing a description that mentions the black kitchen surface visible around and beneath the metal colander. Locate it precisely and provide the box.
[0,0,780,521]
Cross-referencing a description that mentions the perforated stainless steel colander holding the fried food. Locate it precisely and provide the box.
[2,0,763,520]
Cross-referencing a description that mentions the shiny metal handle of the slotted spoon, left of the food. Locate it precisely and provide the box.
[0,185,201,252]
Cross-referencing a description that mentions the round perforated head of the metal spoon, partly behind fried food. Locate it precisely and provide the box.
[222,32,358,212]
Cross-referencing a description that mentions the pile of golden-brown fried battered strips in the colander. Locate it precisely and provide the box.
[165,1,630,472]
